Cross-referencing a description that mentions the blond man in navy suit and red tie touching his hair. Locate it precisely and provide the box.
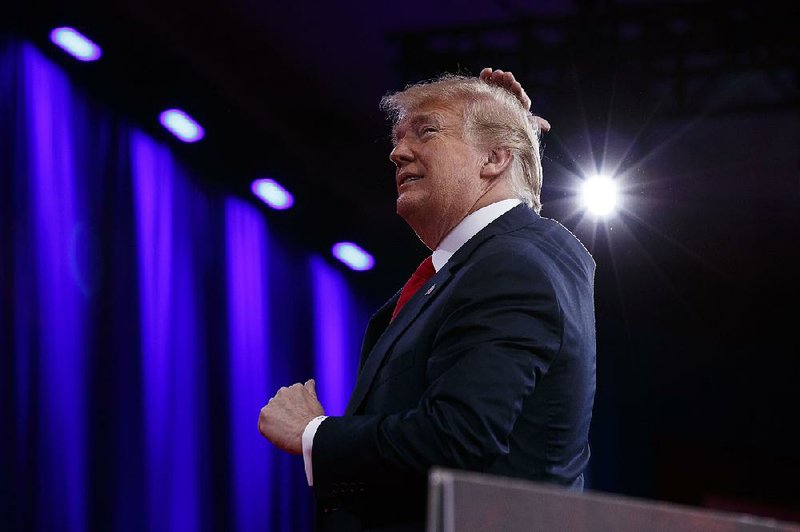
[259,69,595,530]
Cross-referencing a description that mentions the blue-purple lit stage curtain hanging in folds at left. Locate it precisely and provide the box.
[0,39,372,532]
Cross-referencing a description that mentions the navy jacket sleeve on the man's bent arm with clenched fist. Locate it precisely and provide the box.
[312,251,562,495]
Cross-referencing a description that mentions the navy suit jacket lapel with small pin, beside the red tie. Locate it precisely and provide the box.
[345,205,538,415]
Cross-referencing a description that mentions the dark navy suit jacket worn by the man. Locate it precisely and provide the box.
[312,204,595,531]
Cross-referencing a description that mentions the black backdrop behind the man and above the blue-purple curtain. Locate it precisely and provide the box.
[4,0,800,520]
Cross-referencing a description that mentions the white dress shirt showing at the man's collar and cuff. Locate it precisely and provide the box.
[303,198,522,486]
